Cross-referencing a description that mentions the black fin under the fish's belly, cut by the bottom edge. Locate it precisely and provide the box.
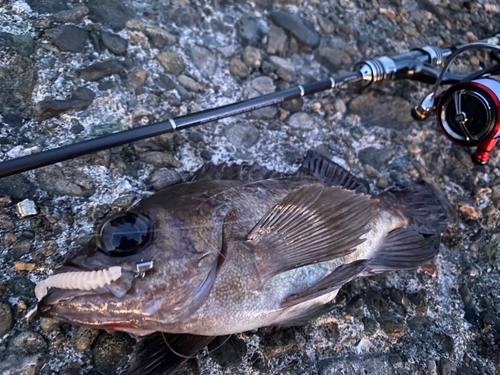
[125,332,214,375]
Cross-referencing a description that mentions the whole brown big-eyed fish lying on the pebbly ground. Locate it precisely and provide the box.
[36,150,453,374]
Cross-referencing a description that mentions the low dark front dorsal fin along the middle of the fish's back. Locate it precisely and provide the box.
[188,163,287,182]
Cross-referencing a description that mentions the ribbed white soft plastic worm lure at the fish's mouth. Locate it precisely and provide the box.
[35,267,122,301]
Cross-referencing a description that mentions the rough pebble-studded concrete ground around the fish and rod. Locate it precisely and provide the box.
[0,0,500,375]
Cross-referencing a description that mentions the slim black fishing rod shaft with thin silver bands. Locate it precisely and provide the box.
[0,72,362,178]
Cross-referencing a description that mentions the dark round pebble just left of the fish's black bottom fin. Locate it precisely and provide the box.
[92,332,134,374]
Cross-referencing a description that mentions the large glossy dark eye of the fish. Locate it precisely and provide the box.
[96,212,153,256]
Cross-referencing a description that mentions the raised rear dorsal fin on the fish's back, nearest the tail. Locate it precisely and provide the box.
[297,150,368,193]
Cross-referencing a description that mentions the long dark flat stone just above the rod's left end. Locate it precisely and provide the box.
[36,87,95,122]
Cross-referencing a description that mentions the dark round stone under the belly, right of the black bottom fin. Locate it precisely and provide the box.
[208,335,247,369]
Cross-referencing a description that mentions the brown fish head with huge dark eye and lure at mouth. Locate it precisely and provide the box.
[38,194,221,334]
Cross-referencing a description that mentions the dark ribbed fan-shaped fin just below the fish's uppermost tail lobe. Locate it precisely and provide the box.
[367,228,437,274]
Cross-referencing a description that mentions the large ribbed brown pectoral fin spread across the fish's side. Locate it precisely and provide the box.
[247,184,378,282]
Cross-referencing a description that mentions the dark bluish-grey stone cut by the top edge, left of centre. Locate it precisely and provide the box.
[86,0,136,31]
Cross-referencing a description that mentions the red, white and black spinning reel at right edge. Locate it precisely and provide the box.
[412,43,500,165]
